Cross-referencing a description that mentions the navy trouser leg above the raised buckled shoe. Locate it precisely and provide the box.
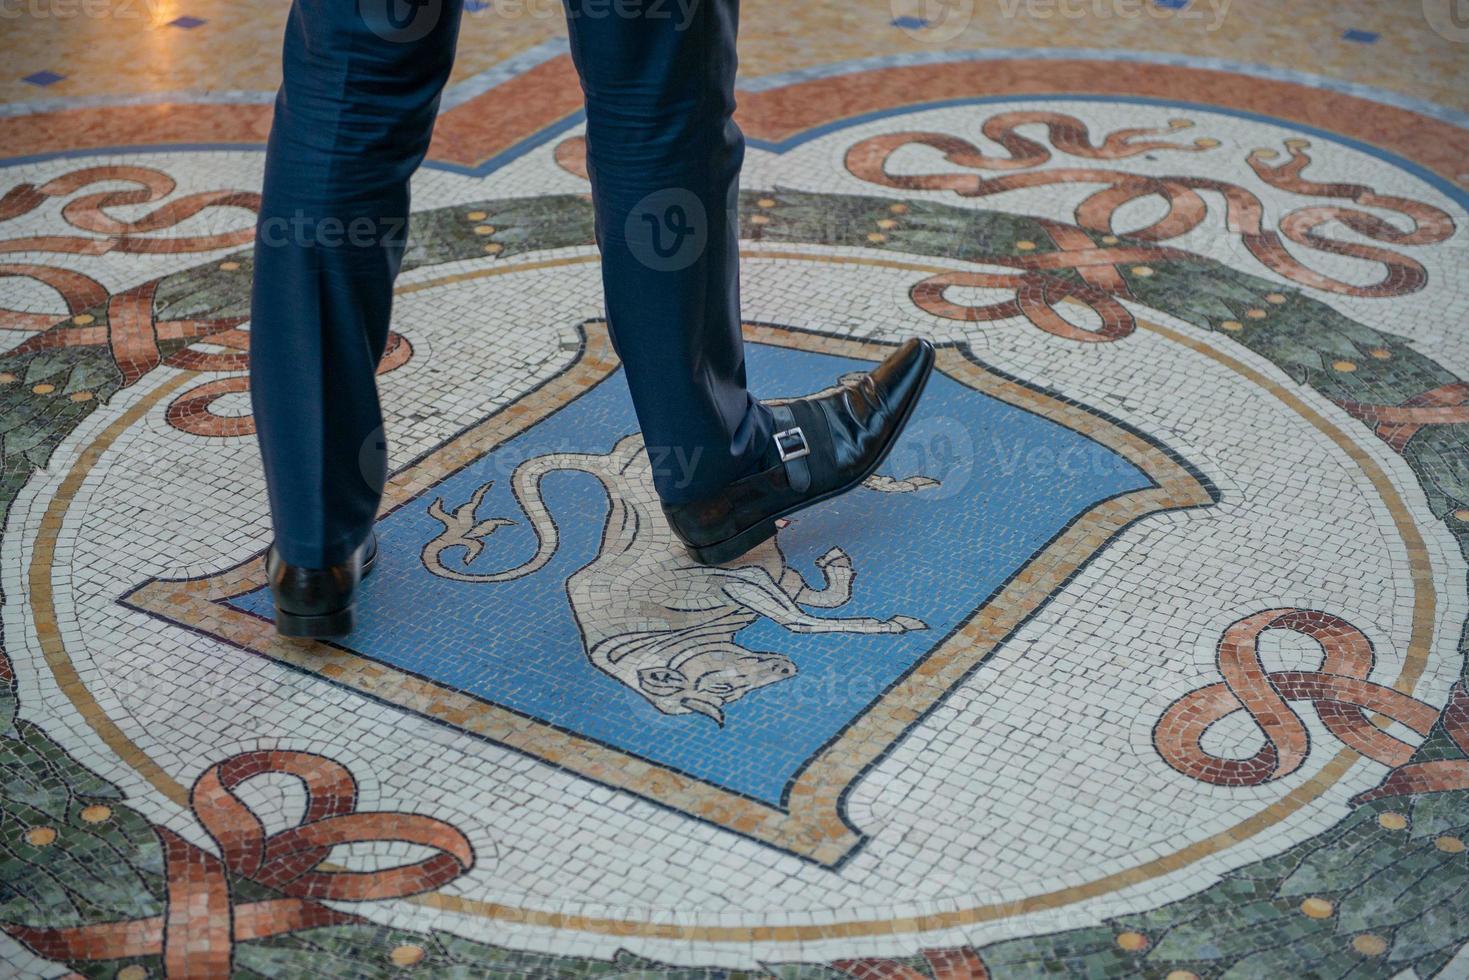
[566,0,771,502]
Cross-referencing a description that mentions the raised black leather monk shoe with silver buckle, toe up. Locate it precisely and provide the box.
[663,338,934,564]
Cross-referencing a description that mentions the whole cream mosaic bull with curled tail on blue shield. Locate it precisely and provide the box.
[423,433,937,726]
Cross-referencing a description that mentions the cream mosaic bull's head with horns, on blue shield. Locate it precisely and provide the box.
[638,644,796,726]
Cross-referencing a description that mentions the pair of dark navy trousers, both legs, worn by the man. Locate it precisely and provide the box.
[251,0,770,567]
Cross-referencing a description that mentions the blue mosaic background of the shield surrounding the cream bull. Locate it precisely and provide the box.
[232,344,1150,805]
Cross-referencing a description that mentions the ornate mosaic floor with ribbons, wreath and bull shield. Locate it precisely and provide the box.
[0,0,1469,980]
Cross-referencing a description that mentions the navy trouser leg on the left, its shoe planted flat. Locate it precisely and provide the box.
[250,0,460,569]
